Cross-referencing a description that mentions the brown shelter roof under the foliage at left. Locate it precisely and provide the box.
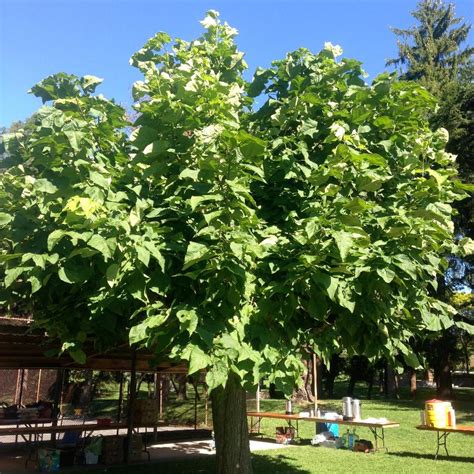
[0,316,187,373]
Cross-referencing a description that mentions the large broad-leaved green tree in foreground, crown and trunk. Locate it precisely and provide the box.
[0,11,469,473]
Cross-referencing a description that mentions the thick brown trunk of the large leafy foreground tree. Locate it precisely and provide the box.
[211,373,252,474]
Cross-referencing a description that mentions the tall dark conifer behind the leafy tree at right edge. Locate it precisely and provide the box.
[387,0,474,398]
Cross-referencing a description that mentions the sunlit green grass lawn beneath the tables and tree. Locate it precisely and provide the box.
[75,383,474,474]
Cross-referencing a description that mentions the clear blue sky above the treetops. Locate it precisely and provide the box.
[0,0,474,126]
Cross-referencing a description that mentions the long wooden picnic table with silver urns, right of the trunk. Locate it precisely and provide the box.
[247,412,400,451]
